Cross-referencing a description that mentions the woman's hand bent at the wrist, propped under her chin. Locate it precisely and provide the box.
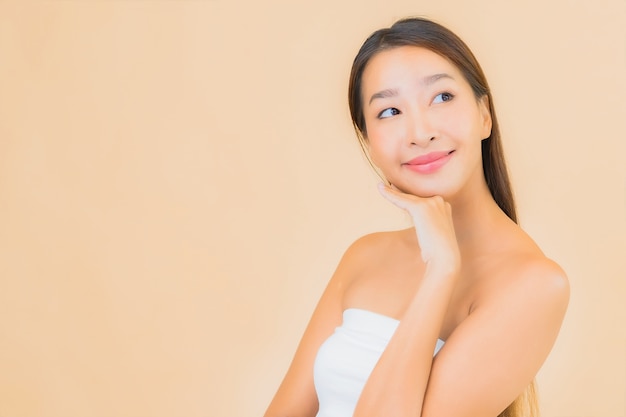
[378,184,461,274]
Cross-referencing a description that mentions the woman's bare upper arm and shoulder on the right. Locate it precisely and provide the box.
[422,261,569,417]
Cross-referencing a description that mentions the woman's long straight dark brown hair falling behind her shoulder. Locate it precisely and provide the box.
[348,18,538,417]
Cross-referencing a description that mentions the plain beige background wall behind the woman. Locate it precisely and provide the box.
[0,0,626,417]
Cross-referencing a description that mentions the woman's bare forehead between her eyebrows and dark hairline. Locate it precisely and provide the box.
[361,46,465,95]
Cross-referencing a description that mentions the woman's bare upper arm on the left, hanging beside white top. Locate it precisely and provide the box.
[265,236,362,417]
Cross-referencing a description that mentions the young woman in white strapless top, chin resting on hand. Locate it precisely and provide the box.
[265,19,569,417]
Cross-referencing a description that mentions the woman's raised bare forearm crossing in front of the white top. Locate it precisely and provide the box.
[354,269,457,417]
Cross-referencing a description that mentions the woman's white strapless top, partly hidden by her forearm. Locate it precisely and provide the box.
[313,308,444,417]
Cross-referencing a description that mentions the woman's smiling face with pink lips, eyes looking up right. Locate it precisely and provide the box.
[361,46,491,199]
